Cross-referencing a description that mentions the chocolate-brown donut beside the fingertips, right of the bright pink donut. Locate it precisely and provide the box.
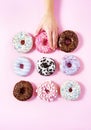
[58,30,78,52]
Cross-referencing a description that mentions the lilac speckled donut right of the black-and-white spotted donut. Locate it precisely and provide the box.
[60,55,80,75]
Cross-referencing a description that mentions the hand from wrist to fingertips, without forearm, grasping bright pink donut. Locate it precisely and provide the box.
[36,13,58,50]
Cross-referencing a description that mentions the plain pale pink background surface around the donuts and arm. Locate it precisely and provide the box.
[0,0,91,130]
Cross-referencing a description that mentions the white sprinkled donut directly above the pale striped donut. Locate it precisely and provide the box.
[12,32,33,53]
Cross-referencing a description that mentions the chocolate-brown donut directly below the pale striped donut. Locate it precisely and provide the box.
[13,80,33,101]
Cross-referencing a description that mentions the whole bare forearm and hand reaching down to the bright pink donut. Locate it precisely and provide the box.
[36,0,58,50]
